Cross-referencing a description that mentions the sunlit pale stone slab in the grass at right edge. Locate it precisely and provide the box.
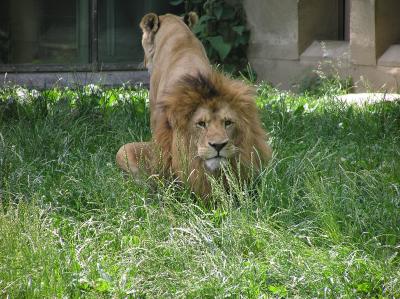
[337,93,400,106]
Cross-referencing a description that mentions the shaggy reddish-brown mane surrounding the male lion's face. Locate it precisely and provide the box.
[154,71,271,194]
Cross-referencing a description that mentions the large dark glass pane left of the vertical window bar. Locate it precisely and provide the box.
[0,0,89,64]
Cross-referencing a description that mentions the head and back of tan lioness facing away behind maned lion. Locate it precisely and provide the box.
[140,13,211,131]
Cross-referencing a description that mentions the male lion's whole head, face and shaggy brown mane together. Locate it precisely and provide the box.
[155,71,271,193]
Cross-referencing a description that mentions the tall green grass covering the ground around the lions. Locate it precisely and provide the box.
[0,81,400,298]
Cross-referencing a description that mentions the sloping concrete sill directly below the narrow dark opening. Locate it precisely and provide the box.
[300,41,350,63]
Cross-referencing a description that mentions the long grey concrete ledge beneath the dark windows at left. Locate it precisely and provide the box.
[0,71,149,89]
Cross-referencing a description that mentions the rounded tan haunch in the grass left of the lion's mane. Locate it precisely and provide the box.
[115,142,152,179]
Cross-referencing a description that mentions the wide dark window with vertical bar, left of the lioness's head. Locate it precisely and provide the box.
[0,0,179,71]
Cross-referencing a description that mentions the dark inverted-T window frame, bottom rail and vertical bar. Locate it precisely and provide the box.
[0,0,142,73]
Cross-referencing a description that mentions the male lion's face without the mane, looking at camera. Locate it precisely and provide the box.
[189,103,238,172]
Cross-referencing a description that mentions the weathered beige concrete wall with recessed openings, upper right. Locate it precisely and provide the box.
[243,0,400,91]
